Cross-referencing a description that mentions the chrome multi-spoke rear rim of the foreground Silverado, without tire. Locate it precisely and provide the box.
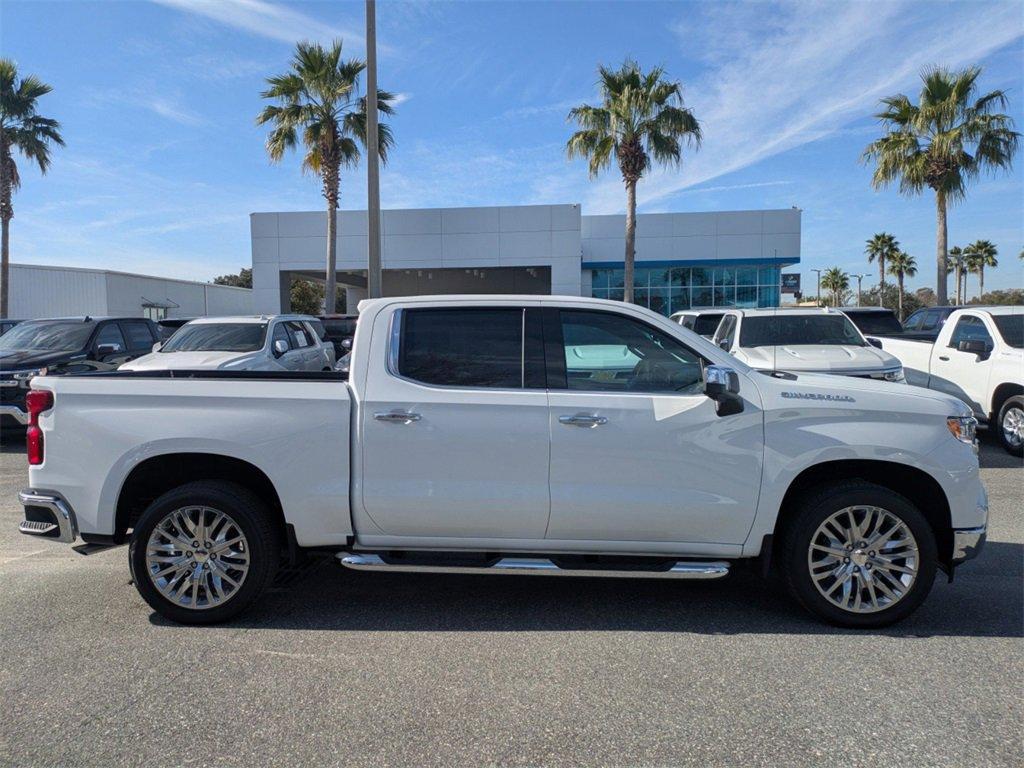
[145,507,249,610]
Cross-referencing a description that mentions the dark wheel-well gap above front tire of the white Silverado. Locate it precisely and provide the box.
[772,459,952,566]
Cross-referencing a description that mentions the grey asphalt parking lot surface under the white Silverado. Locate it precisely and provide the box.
[0,435,1024,767]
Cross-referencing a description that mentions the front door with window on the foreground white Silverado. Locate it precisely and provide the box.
[546,309,764,544]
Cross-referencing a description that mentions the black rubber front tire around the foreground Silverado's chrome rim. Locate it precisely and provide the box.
[780,480,938,629]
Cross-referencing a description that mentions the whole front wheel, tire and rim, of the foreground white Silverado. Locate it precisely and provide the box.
[782,480,937,628]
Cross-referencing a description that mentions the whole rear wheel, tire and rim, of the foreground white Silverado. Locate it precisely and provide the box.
[128,480,281,624]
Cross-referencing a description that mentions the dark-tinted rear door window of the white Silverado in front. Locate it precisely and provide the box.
[397,307,525,389]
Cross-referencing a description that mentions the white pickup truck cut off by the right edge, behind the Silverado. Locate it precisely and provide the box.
[879,306,1024,456]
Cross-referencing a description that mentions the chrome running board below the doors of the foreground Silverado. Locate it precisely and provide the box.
[338,552,729,579]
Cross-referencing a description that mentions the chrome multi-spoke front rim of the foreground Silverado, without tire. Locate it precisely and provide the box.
[807,506,919,613]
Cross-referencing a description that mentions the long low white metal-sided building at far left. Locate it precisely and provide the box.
[8,264,253,319]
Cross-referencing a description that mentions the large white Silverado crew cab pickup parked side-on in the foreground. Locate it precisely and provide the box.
[20,296,987,627]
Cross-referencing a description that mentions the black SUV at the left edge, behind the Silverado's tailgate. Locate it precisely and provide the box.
[0,316,158,426]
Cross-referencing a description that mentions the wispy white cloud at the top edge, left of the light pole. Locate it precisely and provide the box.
[153,0,366,45]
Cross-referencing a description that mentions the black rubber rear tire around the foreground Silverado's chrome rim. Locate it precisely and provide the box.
[128,480,281,624]
